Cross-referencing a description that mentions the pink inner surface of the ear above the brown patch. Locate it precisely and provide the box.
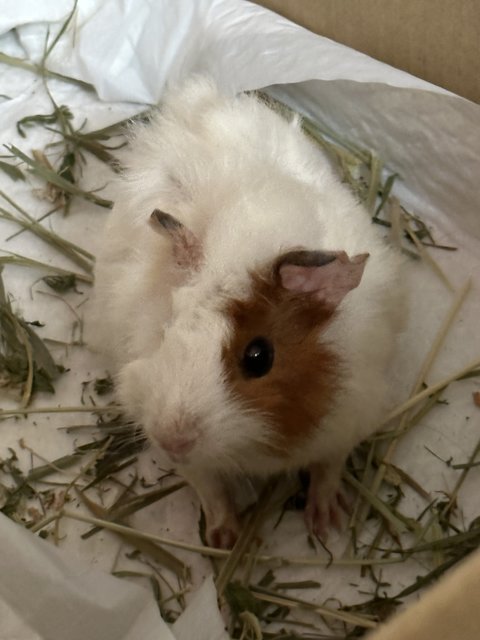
[279,251,368,307]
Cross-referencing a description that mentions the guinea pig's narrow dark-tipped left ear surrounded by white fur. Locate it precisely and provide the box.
[149,209,203,271]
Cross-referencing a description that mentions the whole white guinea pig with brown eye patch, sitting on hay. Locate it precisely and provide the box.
[92,78,404,547]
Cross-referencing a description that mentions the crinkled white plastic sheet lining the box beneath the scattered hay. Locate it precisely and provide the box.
[0,0,480,640]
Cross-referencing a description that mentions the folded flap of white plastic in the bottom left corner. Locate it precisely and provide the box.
[0,515,176,640]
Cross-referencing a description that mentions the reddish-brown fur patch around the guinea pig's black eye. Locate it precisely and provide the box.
[223,269,340,455]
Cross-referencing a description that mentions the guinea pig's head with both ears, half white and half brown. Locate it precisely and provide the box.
[119,218,368,472]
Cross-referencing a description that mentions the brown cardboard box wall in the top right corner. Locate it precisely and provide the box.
[253,0,480,103]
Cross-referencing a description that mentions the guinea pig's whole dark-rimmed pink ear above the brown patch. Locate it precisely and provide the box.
[275,251,369,308]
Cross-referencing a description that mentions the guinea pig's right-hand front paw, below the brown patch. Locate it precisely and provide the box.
[304,464,350,542]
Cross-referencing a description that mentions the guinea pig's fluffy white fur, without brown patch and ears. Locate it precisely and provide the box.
[92,79,404,484]
